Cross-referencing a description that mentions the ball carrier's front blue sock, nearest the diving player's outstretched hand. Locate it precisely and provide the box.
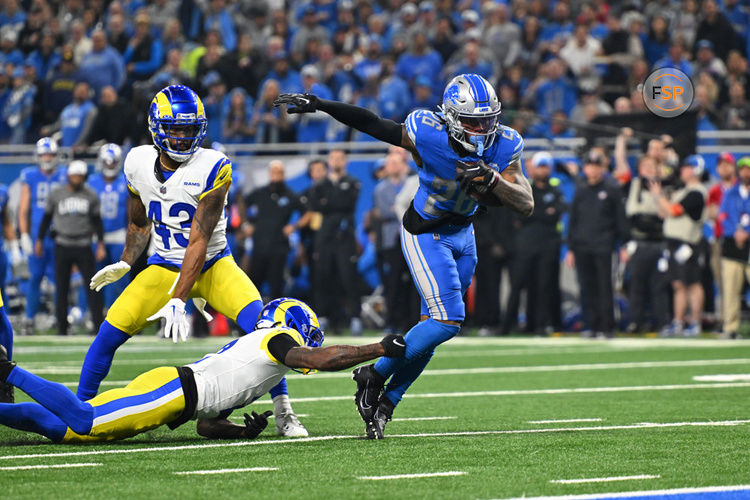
[375,318,461,379]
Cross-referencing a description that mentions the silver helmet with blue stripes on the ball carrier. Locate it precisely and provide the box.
[439,73,500,156]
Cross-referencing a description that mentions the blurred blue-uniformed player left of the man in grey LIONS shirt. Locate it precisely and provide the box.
[18,137,67,333]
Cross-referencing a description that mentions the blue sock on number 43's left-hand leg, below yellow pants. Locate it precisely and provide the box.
[76,321,130,400]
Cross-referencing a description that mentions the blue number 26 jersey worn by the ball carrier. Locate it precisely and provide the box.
[406,109,523,219]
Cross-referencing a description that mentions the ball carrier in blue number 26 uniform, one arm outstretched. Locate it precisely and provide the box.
[276,74,534,439]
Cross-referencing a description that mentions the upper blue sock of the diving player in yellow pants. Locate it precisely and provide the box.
[8,366,94,434]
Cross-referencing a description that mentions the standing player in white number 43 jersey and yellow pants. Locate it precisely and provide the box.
[78,85,307,437]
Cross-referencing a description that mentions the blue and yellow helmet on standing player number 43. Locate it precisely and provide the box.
[148,85,208,163]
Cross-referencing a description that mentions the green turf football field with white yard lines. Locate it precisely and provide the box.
[0,335,750,499]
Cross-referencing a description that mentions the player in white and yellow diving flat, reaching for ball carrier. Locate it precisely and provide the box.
[0,296,405,443]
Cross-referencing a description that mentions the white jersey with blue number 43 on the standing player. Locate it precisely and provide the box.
[124,146,232,267]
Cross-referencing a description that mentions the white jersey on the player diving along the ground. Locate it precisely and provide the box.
[187,327,304,418]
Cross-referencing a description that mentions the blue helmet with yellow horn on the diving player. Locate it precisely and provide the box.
[255,297,325,347]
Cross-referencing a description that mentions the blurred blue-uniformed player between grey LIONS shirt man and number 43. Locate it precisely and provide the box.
[88,144,129,308]
